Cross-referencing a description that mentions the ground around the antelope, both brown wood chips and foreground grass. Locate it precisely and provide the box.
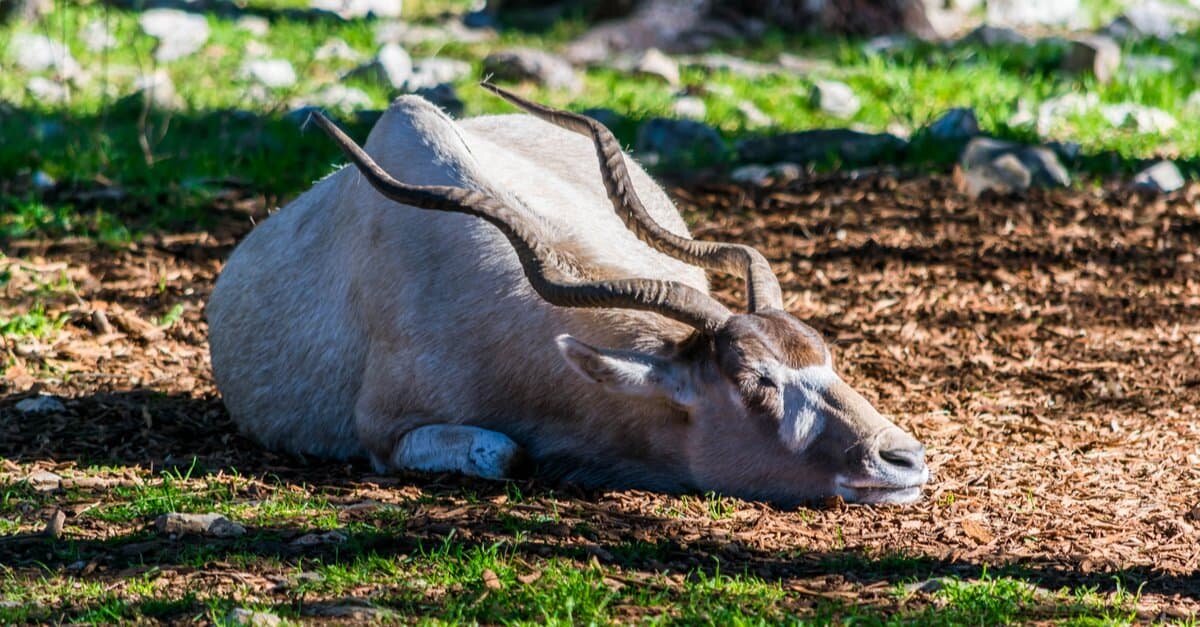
[0,175,1200,625]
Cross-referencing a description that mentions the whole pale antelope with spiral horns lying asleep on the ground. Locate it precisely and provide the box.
[208,83,929,504]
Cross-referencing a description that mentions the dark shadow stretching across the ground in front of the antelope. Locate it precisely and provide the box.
[0,390,1200,610]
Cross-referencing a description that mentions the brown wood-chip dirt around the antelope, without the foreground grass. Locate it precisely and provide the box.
[0,172,1200,619]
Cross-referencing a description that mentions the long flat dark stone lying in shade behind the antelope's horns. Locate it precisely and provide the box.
[738,129,907,166]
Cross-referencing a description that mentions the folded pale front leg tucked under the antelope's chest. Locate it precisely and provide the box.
[389,424,524,479]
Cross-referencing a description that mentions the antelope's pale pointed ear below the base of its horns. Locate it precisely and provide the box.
[556,335,695,406]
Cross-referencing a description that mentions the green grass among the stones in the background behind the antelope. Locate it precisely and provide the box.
[0,0,1200,244]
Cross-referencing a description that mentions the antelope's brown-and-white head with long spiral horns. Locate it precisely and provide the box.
[316,83,929,504]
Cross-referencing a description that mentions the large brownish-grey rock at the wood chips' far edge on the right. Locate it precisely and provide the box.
[959,137,1070,198]
